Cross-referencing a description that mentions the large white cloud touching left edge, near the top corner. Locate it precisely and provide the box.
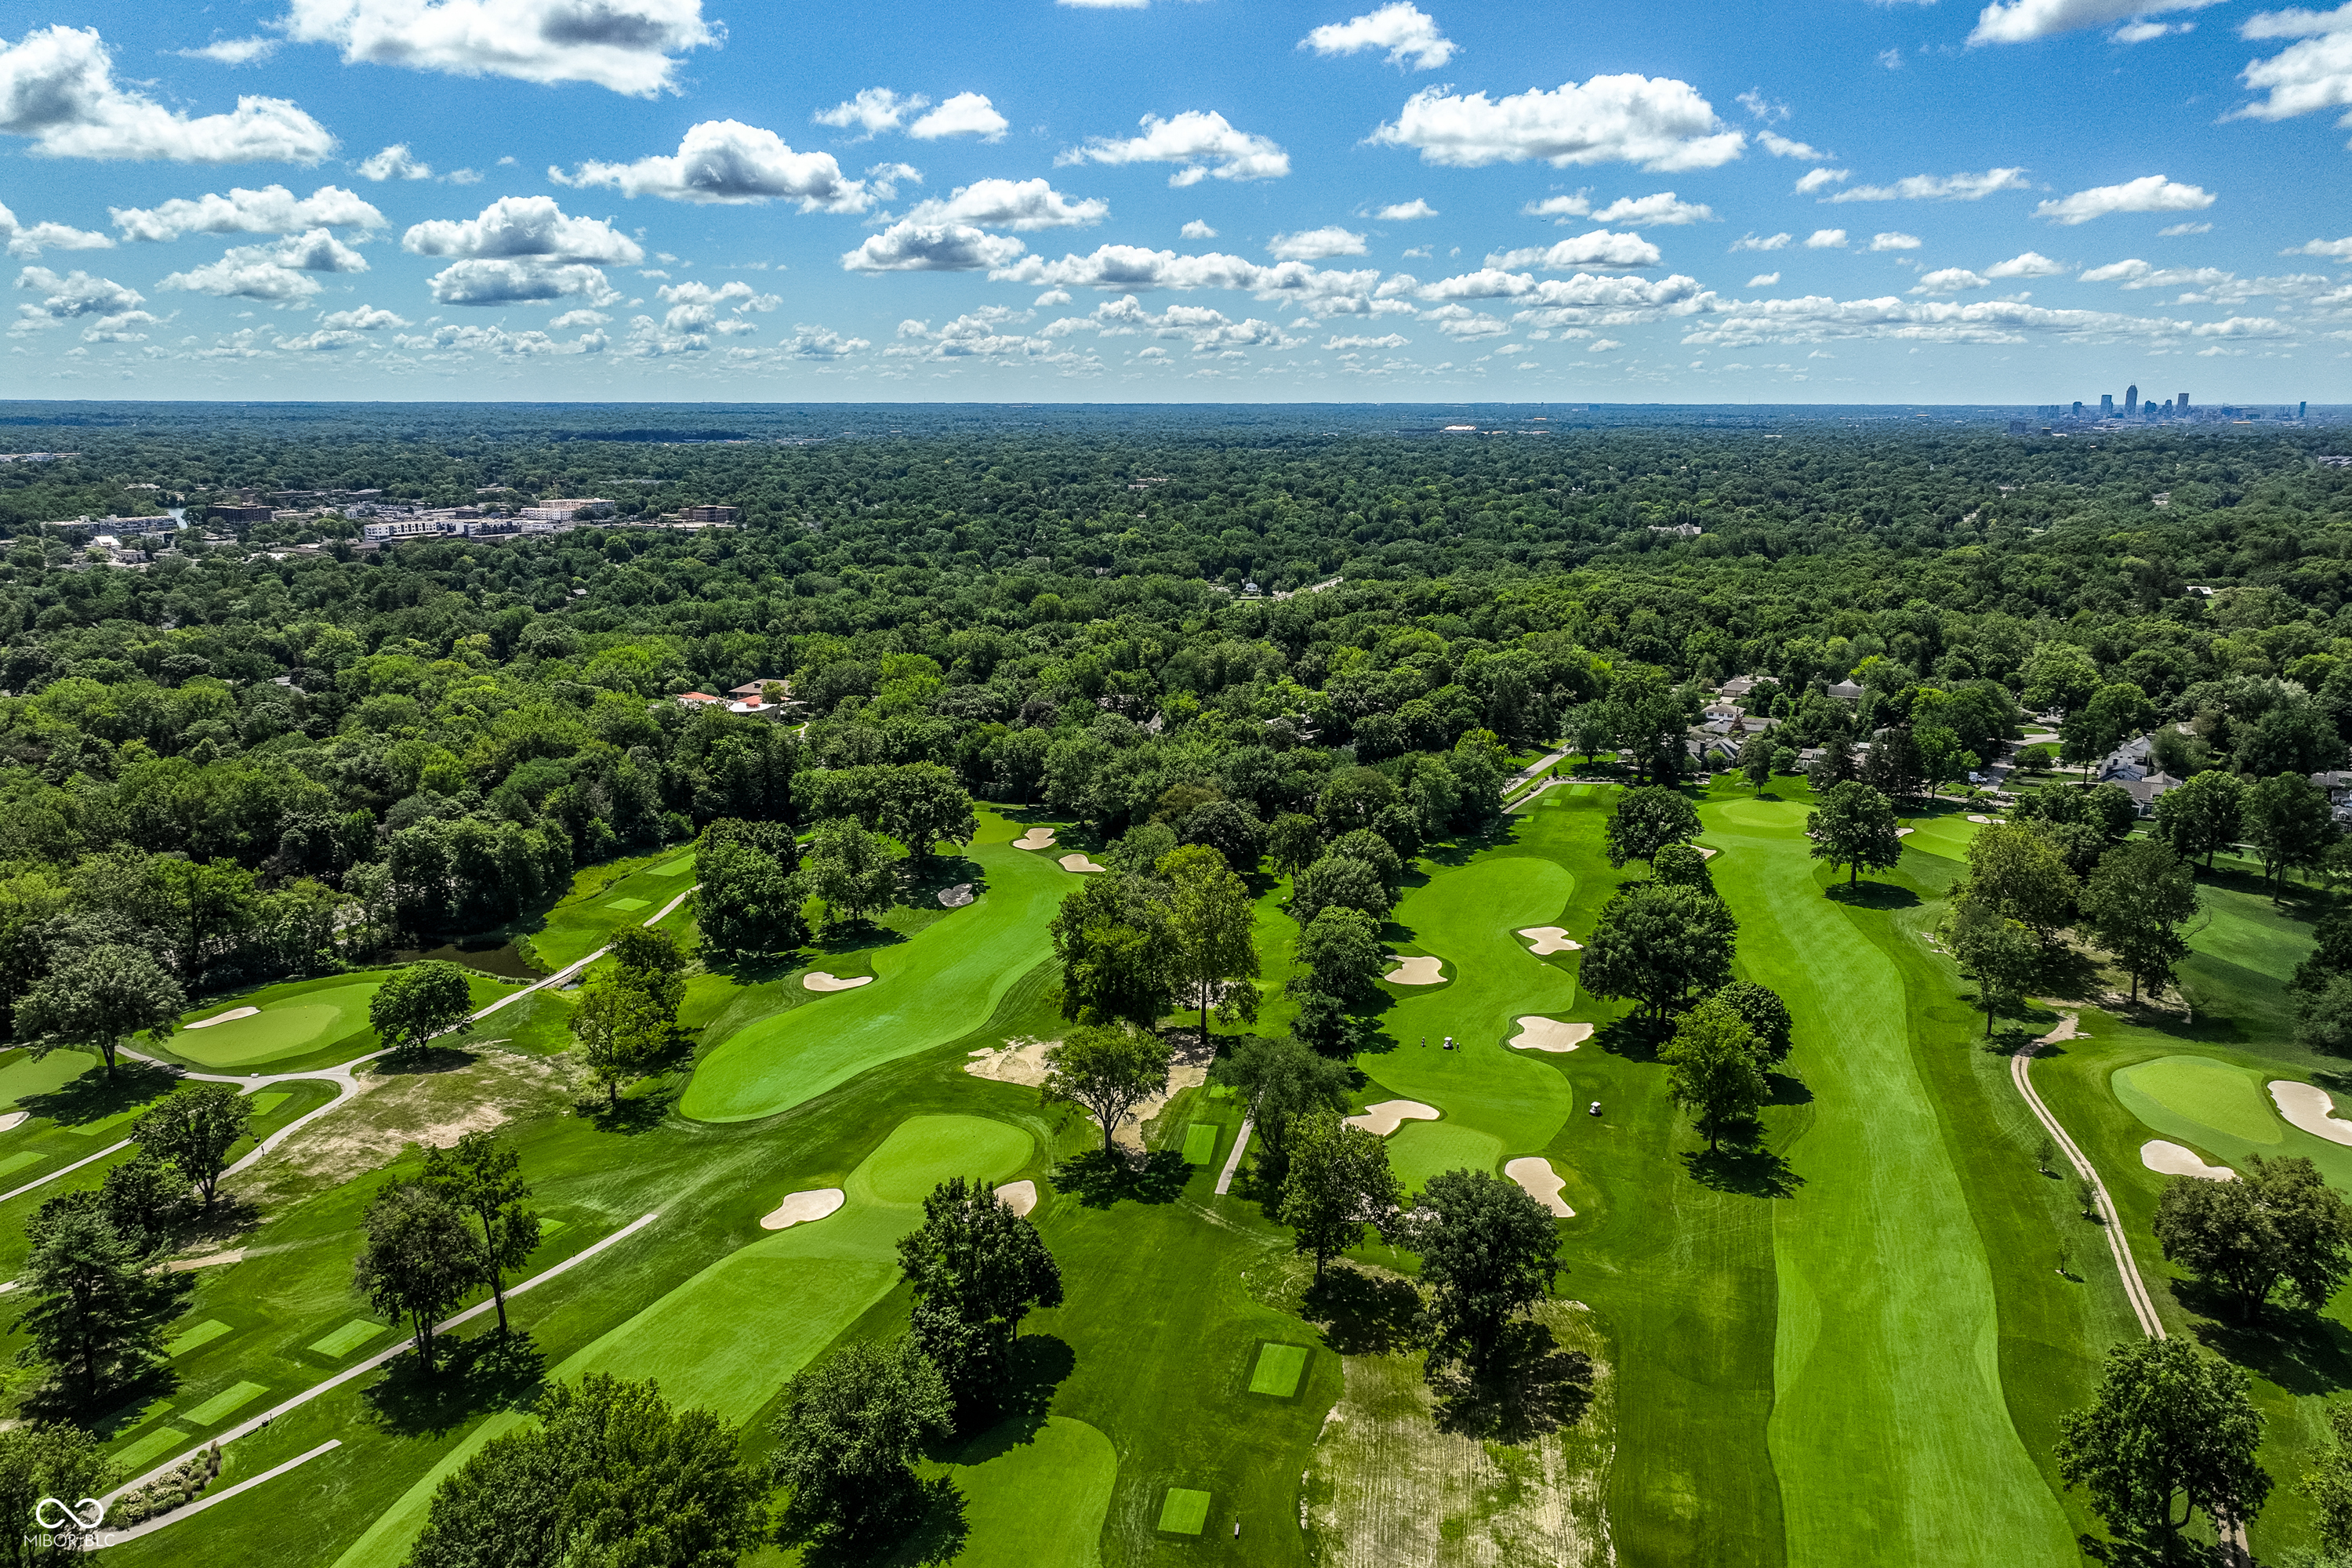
[0,26,334,162]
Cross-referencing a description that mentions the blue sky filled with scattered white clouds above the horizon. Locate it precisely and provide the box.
[0,0,2352,405]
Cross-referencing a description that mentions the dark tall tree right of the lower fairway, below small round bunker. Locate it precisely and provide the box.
[898,1175,1061,1408]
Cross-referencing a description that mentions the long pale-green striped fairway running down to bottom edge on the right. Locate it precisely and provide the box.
[1712,804,2074,1566]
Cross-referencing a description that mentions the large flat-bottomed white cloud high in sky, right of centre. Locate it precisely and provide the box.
[1369,75,1748,172]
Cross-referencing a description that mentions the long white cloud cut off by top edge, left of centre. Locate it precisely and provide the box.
[278,0,720,99]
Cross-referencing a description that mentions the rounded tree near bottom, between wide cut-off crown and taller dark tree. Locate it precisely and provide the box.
[774,1340,955,1547]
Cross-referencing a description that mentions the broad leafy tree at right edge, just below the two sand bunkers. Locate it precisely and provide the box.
[2157,1154,2352,1316]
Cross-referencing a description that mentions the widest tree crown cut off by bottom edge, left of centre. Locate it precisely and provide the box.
[407,1373,767,1568]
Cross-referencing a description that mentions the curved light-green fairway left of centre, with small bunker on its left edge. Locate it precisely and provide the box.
[677,813,1077,1121]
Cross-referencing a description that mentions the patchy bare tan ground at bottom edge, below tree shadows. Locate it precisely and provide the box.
[1301,1298,1616,1568]
